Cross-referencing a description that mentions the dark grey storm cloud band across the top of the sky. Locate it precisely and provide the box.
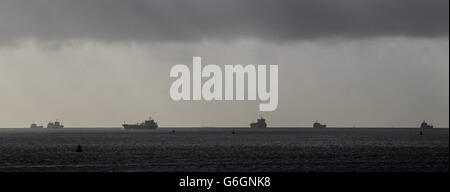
[0,0,449,42]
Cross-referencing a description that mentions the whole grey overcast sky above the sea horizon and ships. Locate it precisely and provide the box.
[0,0,449,128]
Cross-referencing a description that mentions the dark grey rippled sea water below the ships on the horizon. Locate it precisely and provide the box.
[0,128,449,172]
